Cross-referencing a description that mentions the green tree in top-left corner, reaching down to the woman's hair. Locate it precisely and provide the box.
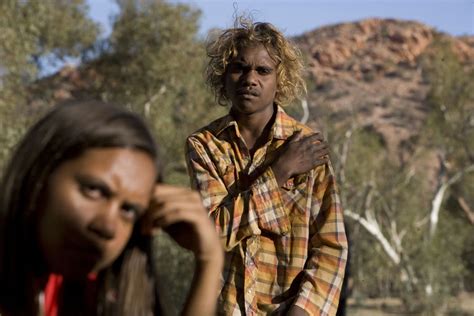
[0,0,99,168]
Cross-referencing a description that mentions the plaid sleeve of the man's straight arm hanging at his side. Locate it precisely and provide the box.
[294,163,348,315]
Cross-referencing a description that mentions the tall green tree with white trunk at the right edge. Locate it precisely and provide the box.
[420,35,474,310]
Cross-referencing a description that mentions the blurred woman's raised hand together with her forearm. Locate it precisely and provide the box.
[142,184,224,316]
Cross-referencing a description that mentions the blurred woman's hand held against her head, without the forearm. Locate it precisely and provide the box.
[142,184,223,261]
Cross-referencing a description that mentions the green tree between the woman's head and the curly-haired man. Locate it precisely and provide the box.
[90,1,223,184]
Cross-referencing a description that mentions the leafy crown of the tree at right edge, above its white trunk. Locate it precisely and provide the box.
[421,37,474,166]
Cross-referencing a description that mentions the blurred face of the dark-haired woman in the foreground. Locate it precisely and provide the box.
[38,148,156,278]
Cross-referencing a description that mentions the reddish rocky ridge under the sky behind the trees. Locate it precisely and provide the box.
[294,19,474,163]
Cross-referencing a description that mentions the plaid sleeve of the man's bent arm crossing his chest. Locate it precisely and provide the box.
[186,137,290,251]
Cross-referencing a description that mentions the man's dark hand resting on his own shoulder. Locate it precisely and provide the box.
[271,131,329,186]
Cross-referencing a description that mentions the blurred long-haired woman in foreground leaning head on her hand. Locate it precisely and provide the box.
[0,101,223,316]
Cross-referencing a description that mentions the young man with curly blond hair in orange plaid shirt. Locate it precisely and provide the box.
[186,19,347,315]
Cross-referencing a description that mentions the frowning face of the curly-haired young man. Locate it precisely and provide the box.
[225,44,277,115]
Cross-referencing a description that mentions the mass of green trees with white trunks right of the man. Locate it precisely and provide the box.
[319,37,474,315]
